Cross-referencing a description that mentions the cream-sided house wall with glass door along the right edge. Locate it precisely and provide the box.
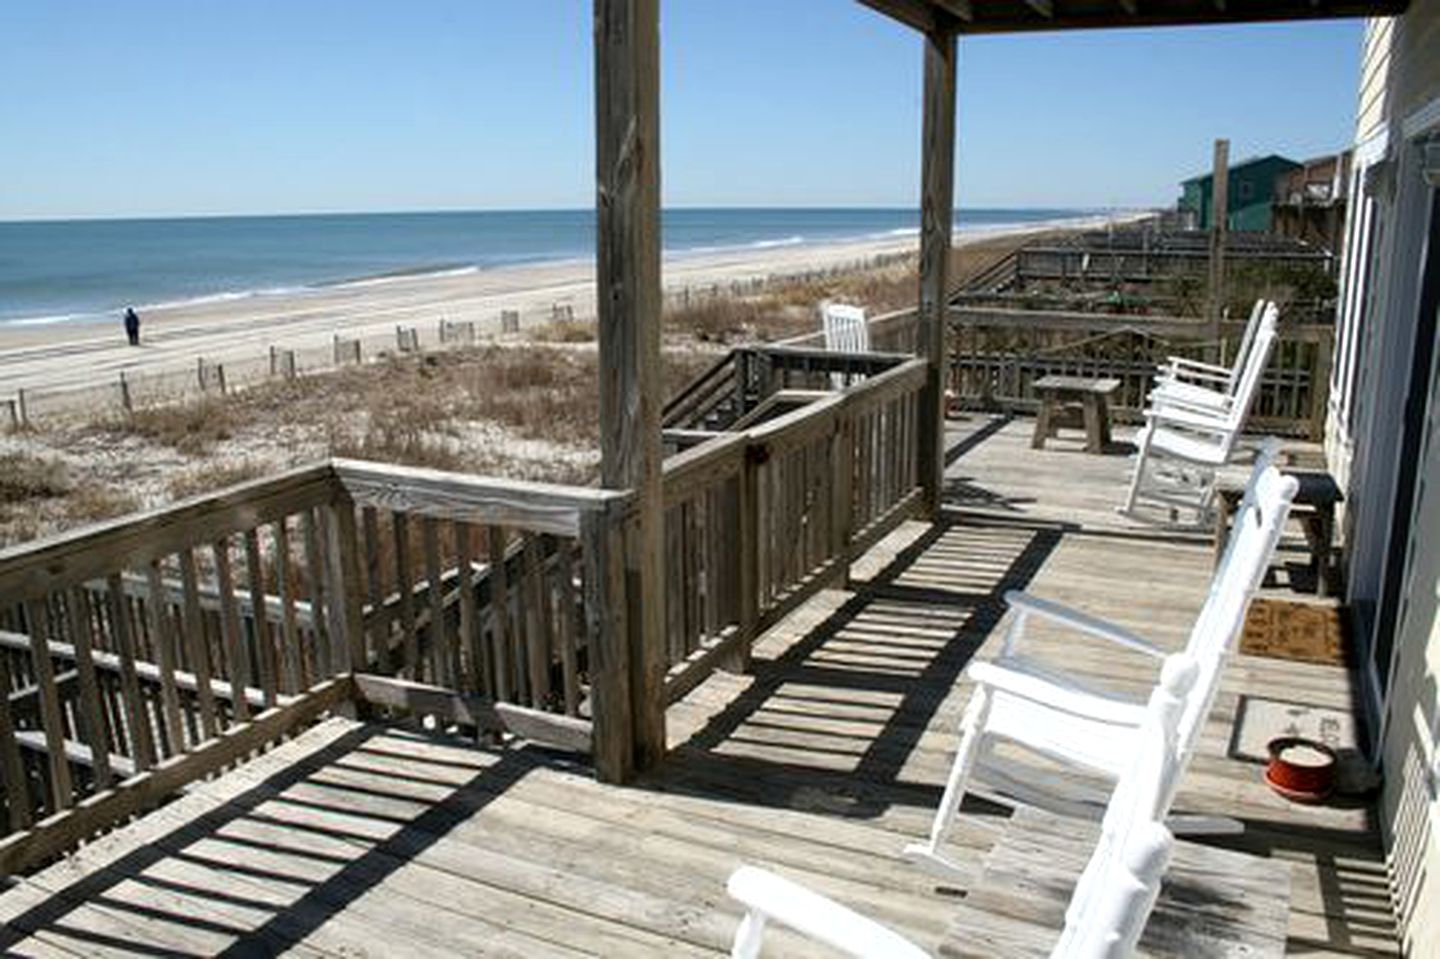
[1326,0,1440,956]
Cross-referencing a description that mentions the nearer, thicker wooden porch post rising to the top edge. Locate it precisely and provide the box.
[595,0,665,778]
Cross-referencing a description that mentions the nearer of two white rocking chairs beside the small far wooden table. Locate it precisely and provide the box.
[1120,305,1277,526]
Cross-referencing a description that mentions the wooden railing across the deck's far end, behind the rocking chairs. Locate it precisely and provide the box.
[949,307,1333,439]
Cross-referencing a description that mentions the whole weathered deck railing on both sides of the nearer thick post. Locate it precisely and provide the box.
[0,339,926,874]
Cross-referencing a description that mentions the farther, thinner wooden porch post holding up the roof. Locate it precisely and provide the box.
[917,22,958,518]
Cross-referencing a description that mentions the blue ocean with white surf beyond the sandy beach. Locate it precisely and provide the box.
[0,207,1097,324]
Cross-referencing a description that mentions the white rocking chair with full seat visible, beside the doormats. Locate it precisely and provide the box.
[904,444,1297,877]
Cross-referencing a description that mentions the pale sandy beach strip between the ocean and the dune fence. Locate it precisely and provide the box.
[0,217,1123,399]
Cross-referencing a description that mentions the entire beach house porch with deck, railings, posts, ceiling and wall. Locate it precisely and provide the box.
[0,0,1440,956]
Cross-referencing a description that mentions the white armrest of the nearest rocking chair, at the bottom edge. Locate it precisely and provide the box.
[726,865,929,959]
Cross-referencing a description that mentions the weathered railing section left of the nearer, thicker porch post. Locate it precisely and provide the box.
[0,461,629,873]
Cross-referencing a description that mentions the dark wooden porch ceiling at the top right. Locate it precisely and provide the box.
[860,0,1408,35]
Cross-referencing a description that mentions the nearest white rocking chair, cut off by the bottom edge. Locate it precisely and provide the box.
[727,654,1198,959]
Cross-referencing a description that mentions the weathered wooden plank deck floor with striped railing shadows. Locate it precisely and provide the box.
[0,419,1392,956]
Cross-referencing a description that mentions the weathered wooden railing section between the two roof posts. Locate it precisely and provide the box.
[664,348,926,701]
